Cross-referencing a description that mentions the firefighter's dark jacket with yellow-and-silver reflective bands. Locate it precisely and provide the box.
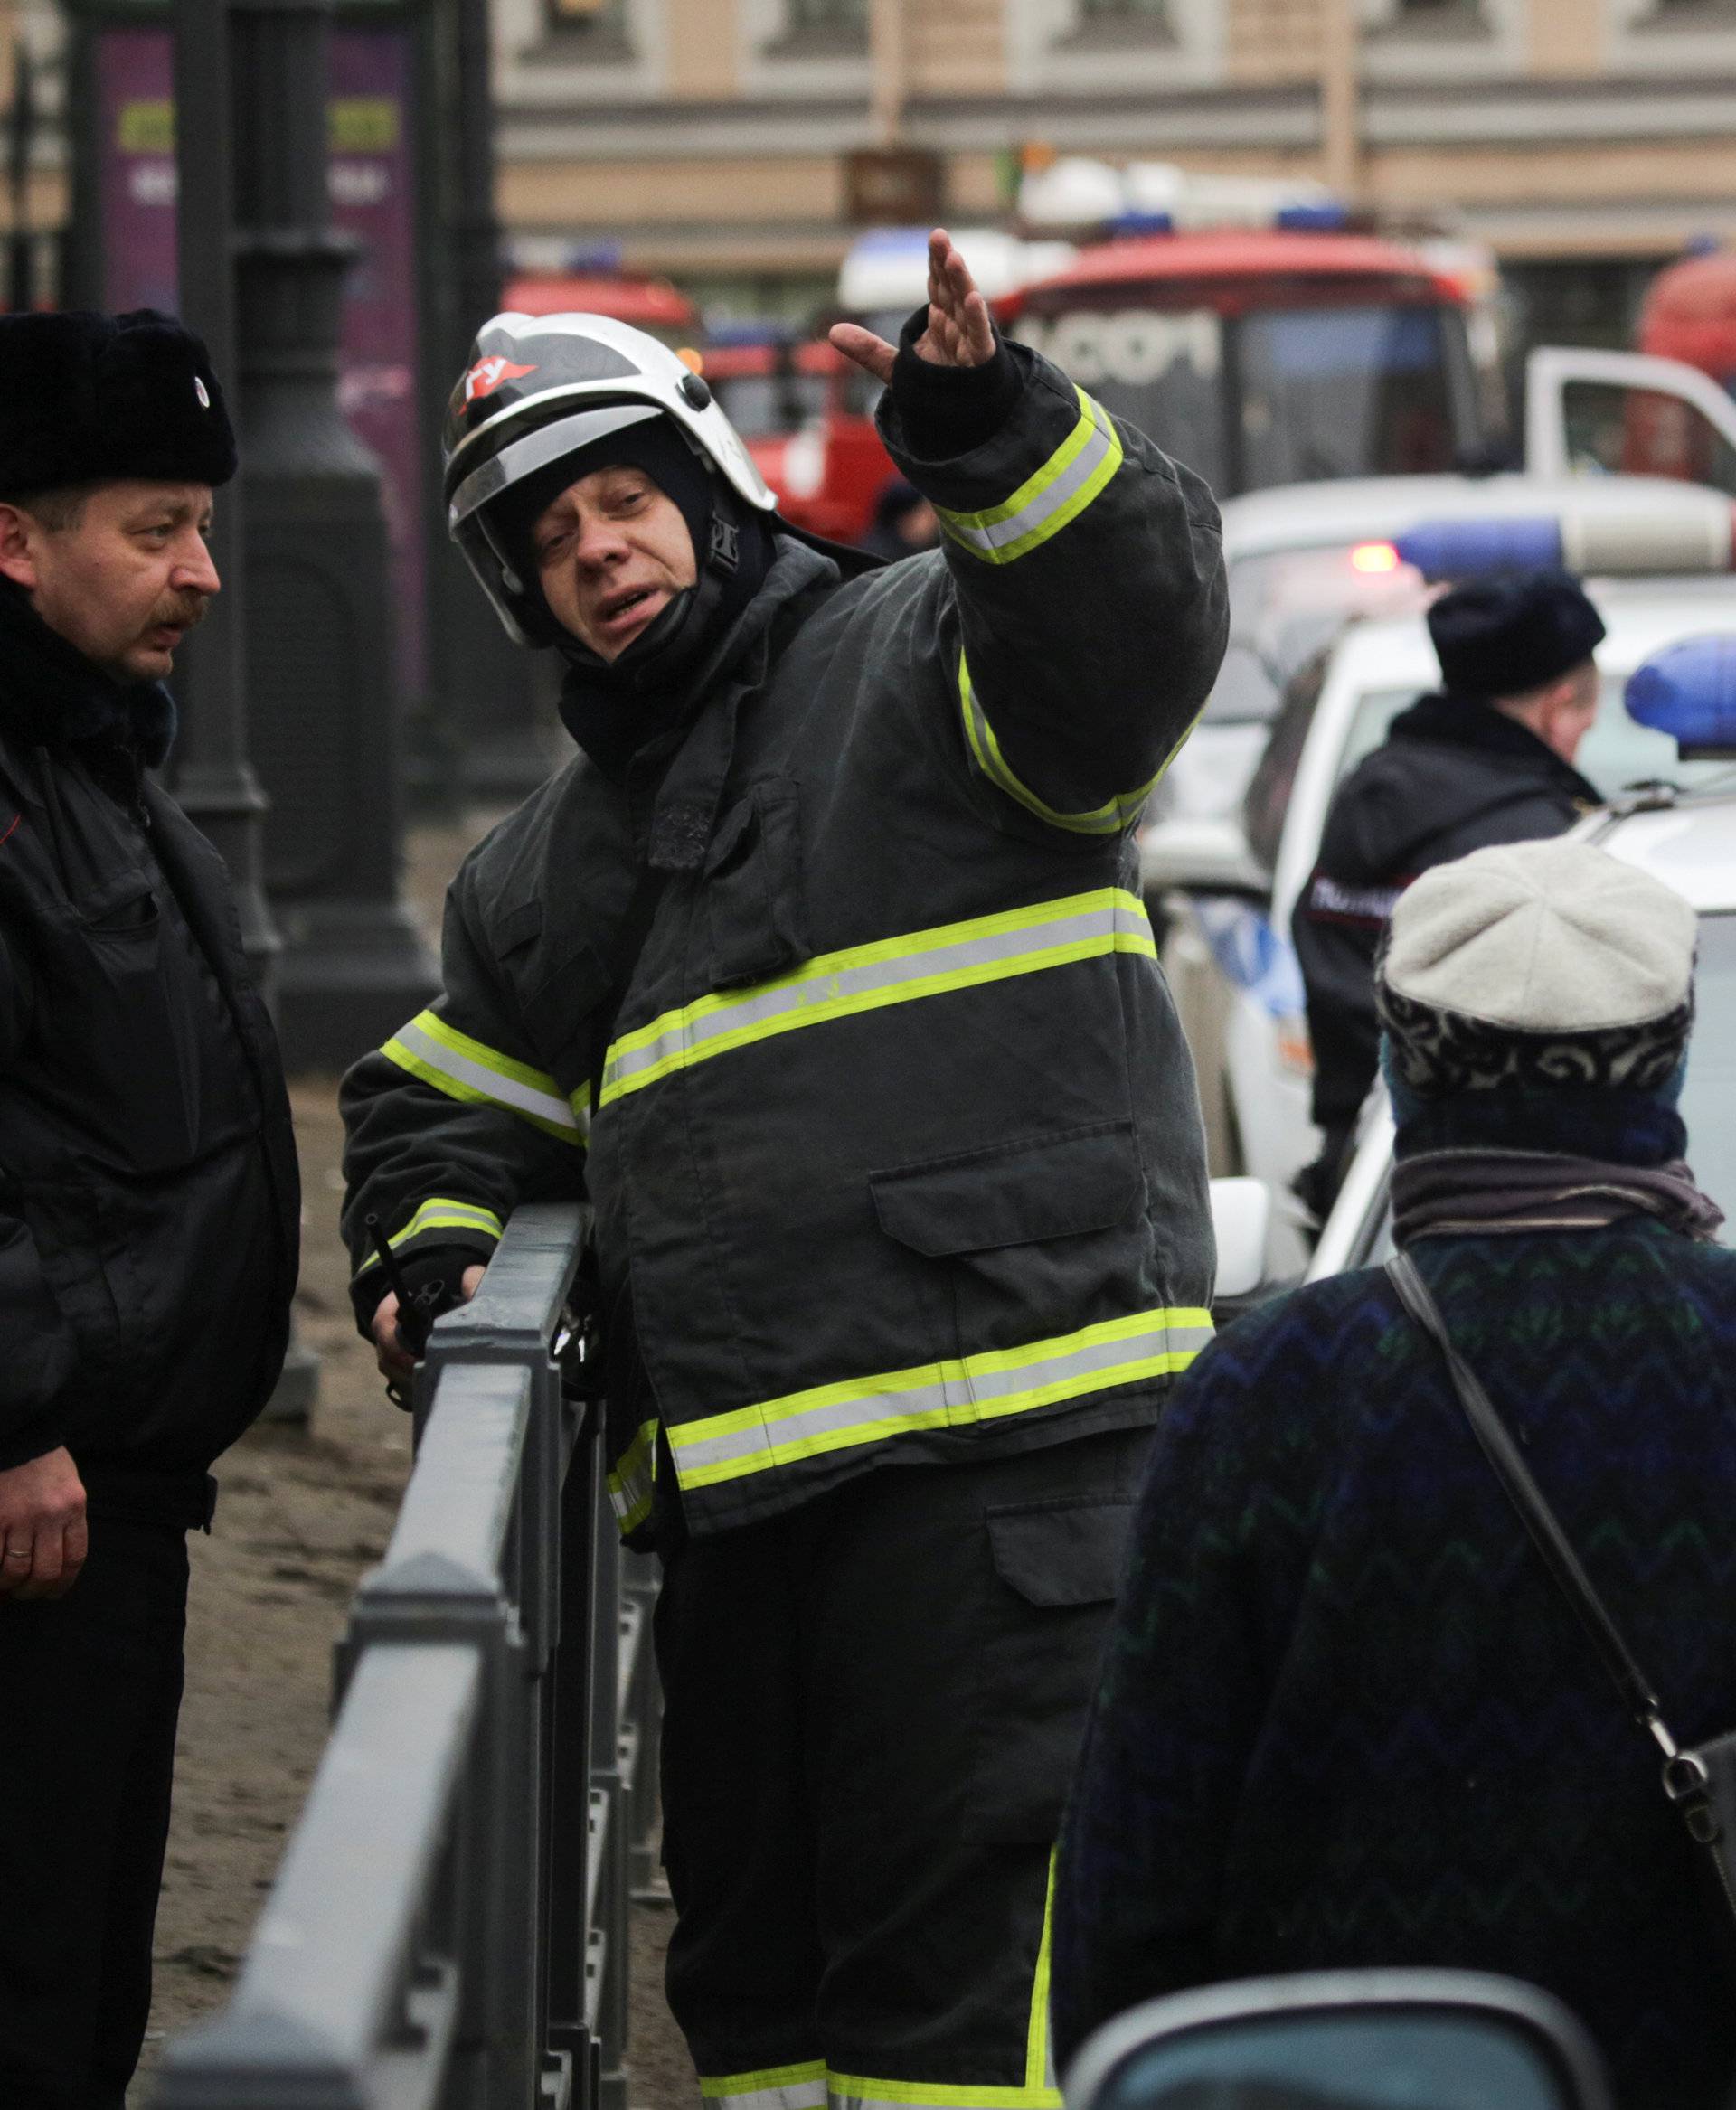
[346,346,1225,1531]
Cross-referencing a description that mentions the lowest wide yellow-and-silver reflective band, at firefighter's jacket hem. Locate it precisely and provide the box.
[669,1313,1211,1485]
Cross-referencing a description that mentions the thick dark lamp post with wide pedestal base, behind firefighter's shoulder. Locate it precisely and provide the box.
[230,0,439,1069]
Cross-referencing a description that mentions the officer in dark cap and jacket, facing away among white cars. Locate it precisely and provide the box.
[1291,572,1603,1218]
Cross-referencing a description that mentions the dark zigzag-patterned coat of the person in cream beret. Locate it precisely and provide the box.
[1054,1093,1736,2110]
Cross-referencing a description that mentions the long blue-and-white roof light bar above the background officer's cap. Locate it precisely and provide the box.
[1392,498,1731,585]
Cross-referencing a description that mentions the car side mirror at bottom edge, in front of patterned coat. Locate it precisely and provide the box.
[1065,1971,1611,2110]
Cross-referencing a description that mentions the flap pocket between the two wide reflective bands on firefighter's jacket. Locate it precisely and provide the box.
[869,1120,1146,1258]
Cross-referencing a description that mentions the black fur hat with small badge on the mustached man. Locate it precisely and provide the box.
[0,308,236,498]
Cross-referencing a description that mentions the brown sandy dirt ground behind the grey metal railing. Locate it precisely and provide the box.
[131,816,698,2110]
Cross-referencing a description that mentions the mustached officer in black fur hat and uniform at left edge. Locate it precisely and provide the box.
[0,310,299,2110]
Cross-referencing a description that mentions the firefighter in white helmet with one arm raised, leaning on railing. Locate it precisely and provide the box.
[344,230,1225,2110]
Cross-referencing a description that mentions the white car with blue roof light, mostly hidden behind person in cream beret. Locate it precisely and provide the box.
[1307,636,1736,1281]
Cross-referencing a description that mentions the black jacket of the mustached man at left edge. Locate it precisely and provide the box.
[0,585,302,1504]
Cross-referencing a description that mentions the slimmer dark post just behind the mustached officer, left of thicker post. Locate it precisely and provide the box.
[175,0,318,1422]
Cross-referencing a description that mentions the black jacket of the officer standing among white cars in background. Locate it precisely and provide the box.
[1291,696,1599,1129]
